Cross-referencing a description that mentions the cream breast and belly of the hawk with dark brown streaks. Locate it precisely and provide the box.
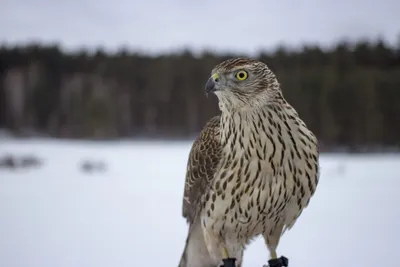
[202,104,318,245]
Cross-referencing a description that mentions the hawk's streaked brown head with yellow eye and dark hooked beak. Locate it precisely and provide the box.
[205,58,283,110]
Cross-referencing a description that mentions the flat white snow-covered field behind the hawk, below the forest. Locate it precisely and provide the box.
[0,140,400,267]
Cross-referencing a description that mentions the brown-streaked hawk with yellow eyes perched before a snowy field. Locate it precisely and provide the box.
[179,58,319,267]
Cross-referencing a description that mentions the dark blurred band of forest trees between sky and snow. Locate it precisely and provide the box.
[0,40,400,151]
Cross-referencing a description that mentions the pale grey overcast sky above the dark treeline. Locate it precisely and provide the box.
[0,0,400,53]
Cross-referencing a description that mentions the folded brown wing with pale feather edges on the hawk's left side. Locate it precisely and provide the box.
[182,116,222,224]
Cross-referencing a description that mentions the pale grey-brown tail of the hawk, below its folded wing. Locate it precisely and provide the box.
[178,221,217,267]
